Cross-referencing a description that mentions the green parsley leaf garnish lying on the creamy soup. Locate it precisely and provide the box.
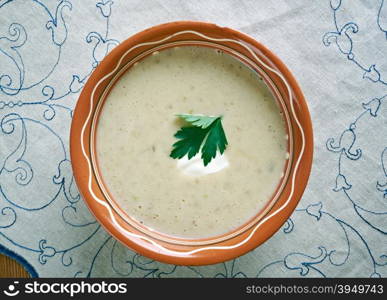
[170,114,228,166]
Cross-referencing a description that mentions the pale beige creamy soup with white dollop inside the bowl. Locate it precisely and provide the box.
[96,46,287,238]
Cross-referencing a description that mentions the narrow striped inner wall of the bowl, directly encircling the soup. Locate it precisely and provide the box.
[90,40,293,246]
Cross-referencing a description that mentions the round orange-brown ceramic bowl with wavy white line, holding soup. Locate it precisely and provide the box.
[70,22,313,265]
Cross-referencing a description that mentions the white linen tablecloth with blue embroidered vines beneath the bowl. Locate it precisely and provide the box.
[0,0,387,277]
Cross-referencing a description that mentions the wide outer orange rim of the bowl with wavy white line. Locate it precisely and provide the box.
[70,21,313,265]
